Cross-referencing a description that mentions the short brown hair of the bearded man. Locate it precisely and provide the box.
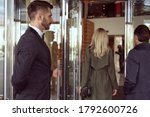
[27,0,53,20]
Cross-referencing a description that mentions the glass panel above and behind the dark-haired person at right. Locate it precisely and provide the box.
[126,0,150,53]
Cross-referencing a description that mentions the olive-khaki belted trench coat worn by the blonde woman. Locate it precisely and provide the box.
[81,48,118,100]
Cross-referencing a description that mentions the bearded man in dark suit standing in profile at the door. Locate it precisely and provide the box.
[12,1,57,100]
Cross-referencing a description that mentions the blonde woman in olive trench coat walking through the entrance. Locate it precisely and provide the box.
[81,28,118,100]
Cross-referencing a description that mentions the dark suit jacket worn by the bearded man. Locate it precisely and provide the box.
[12,27,52,100]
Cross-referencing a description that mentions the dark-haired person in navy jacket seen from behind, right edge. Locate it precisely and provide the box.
[124,25,150,100]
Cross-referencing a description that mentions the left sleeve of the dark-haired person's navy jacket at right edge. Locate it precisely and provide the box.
[124,52,139,95]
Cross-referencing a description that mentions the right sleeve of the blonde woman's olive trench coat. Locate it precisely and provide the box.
[108,49,118,89]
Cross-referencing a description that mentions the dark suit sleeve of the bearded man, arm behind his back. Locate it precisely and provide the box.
[12,39,37,92]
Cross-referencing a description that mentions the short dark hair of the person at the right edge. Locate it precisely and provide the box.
[134,25,150,42]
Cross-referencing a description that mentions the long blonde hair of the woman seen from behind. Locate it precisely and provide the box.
[90,28,108,58]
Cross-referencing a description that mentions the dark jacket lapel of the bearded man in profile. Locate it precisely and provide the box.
[27,27,49,52]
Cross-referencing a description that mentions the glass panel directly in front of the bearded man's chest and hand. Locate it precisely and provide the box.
[48,24,62,100]
